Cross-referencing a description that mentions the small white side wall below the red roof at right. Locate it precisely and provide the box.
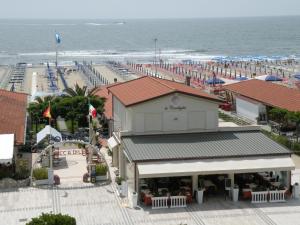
[236,97,260,121]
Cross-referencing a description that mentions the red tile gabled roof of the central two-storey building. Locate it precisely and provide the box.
[108,76,222,106]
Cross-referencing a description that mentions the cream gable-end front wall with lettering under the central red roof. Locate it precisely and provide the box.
[130,94,218,134]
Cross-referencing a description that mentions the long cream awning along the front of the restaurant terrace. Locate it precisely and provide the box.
[137,156,295,178]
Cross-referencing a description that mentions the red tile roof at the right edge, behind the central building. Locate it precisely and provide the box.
[224,79,300,111]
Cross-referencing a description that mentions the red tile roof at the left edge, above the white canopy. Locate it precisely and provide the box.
[0,90,28,144]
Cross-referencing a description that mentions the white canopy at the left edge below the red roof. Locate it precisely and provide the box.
[0,134,14,164]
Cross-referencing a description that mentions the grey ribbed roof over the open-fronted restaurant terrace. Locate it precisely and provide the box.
[122,131,291,161]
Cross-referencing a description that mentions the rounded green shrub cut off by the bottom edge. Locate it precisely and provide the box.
[26,213,76,225]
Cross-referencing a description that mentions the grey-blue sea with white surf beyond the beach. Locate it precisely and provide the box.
[0,16,300,65]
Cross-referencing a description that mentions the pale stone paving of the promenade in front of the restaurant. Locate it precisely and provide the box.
[0,148,300,225]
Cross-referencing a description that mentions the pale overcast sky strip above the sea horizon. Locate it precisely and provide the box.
[0,0,300,19]
